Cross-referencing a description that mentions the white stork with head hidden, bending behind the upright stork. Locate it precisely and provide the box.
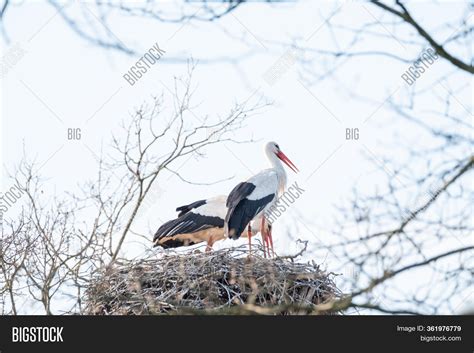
[153,196,263,252]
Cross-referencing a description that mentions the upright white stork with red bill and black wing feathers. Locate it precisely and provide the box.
[224,142,299,257]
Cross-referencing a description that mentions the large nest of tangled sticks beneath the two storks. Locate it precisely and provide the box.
[85,248,342,315]
